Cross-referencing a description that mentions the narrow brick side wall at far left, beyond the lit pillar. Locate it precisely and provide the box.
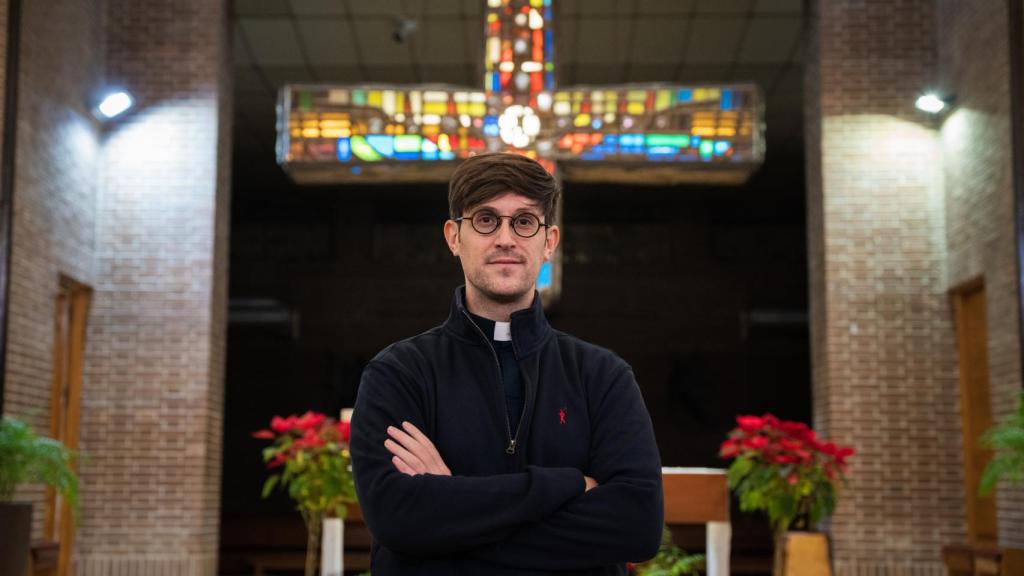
[2,0,102,538]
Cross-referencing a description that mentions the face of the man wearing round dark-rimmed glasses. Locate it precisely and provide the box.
[444,192,559,305]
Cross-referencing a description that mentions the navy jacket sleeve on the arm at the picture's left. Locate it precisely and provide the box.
[350,360,585,556]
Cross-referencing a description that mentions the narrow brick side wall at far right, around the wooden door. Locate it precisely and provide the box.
[938,0,1024,548]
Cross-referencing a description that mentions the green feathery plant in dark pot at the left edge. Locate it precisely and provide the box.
[0,417,79,574]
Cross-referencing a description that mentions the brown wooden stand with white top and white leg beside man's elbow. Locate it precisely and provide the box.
[662,467,732,576]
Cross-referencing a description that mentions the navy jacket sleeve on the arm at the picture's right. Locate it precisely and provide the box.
[472,366,665,570]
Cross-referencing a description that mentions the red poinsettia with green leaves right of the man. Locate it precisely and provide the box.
[719,414,854,535]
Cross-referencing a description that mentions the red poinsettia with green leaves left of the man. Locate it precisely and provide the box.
[253,412,355,524]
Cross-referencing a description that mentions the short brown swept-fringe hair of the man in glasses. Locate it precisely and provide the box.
[449,152,560,223]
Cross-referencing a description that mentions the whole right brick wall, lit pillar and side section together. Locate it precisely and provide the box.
[806,0,1024,575]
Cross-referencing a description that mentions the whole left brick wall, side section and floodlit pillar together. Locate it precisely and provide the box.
[0,0,230,575]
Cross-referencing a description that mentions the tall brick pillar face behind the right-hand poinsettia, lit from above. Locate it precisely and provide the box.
[806,0,965,576]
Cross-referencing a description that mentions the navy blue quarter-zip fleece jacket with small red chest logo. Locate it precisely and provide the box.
[351,288,664,576]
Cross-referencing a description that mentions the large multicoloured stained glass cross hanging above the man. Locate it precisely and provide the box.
[278,0,764,295]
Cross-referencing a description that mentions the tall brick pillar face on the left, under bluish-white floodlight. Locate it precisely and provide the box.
[78,0,229,575]
